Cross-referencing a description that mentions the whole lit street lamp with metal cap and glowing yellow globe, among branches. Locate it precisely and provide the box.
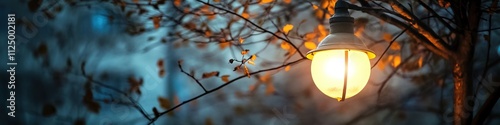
[307,0,375,101]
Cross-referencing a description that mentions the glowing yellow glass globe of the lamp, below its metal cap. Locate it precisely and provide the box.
[311,50,371,99]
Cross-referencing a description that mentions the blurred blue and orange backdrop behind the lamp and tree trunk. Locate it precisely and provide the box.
[0,0,500,125]
